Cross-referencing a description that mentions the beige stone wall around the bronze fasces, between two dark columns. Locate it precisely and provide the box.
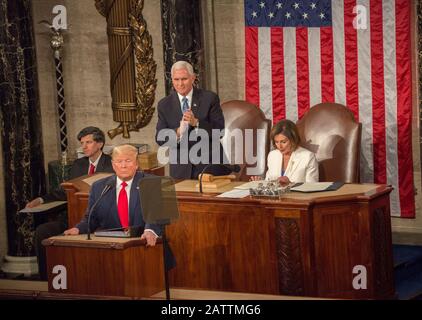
[33,0,164,166]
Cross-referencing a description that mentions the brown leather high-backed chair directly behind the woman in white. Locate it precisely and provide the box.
[297,103,362,183]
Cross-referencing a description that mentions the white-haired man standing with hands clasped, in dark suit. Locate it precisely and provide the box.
[155,61,230,179]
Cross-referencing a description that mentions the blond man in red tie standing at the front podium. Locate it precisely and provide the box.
[64,144,161,246]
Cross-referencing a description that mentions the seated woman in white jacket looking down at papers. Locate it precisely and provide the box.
[251,120,319,185]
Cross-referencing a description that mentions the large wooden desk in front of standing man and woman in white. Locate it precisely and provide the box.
[61,182,394,299]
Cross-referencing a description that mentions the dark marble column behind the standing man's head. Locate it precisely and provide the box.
[161,0,204,94]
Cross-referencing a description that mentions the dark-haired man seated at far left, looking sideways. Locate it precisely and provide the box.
[26,127,114,280]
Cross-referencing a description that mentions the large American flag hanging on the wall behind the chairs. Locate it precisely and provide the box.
[245,0,415,218]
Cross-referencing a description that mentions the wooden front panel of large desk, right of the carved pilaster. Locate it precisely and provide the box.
[313,204,371,296]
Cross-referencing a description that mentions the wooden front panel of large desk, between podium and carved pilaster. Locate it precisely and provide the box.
[167,201,278,293]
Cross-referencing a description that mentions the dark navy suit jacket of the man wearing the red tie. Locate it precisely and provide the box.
[76,172,162,235]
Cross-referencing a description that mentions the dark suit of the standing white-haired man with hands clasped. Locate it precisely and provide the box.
[155,88,224,179]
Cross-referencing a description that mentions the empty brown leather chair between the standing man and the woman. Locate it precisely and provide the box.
[221,100,271,181]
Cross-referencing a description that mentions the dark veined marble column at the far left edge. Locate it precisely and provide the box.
[0,0,45,273]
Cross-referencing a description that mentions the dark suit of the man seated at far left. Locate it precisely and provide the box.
[35,153,114,280]
